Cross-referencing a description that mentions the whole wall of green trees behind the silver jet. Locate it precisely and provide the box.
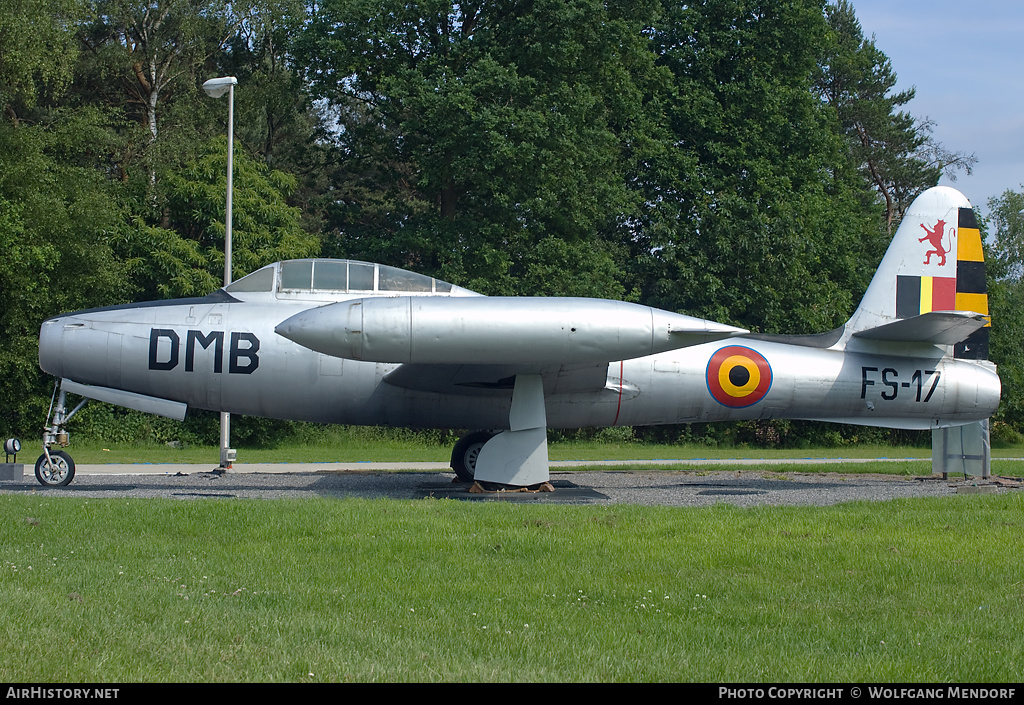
[0,0,999,440]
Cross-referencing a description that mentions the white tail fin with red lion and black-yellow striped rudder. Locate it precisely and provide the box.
[846,186,991,360]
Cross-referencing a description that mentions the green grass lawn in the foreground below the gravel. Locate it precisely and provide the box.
[0,490,1024,682]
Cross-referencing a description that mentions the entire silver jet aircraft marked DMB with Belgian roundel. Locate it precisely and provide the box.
[36,188,999,487]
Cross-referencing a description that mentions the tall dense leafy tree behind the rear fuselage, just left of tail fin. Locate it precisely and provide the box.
[634,0,878,332]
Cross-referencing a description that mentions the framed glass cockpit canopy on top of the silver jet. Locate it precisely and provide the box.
[224,259,474,299]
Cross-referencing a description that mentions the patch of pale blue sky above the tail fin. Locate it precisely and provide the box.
[851,0,1024,214]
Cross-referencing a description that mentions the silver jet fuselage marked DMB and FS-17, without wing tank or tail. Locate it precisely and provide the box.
[40,293,999,429]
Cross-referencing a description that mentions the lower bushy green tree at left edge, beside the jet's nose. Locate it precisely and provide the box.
[0,112,128,433]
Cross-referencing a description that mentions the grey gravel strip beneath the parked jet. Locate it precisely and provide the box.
[0,470,1021,507]
